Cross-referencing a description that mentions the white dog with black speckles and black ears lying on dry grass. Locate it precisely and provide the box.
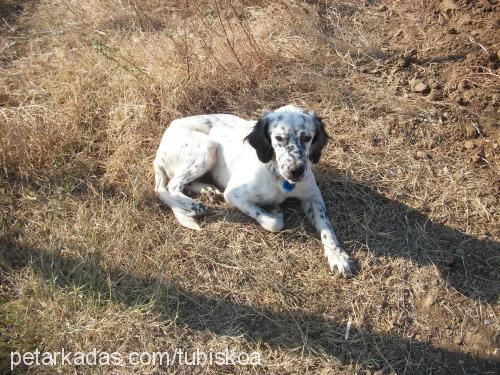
[153,105,353,276]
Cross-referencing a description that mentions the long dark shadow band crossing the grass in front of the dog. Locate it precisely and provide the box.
[0,239,498,374]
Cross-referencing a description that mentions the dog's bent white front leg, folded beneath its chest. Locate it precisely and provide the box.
[224,186,284,232]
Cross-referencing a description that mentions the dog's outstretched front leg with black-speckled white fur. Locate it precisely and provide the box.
[301,190,353,277]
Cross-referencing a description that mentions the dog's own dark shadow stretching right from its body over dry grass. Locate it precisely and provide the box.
[200,169,500,303]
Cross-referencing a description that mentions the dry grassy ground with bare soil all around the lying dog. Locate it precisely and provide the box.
[0,0,500,375]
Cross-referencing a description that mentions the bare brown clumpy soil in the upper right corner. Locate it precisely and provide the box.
[356,0,500,181]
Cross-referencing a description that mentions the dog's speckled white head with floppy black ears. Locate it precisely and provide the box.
[245,105,328,182]
